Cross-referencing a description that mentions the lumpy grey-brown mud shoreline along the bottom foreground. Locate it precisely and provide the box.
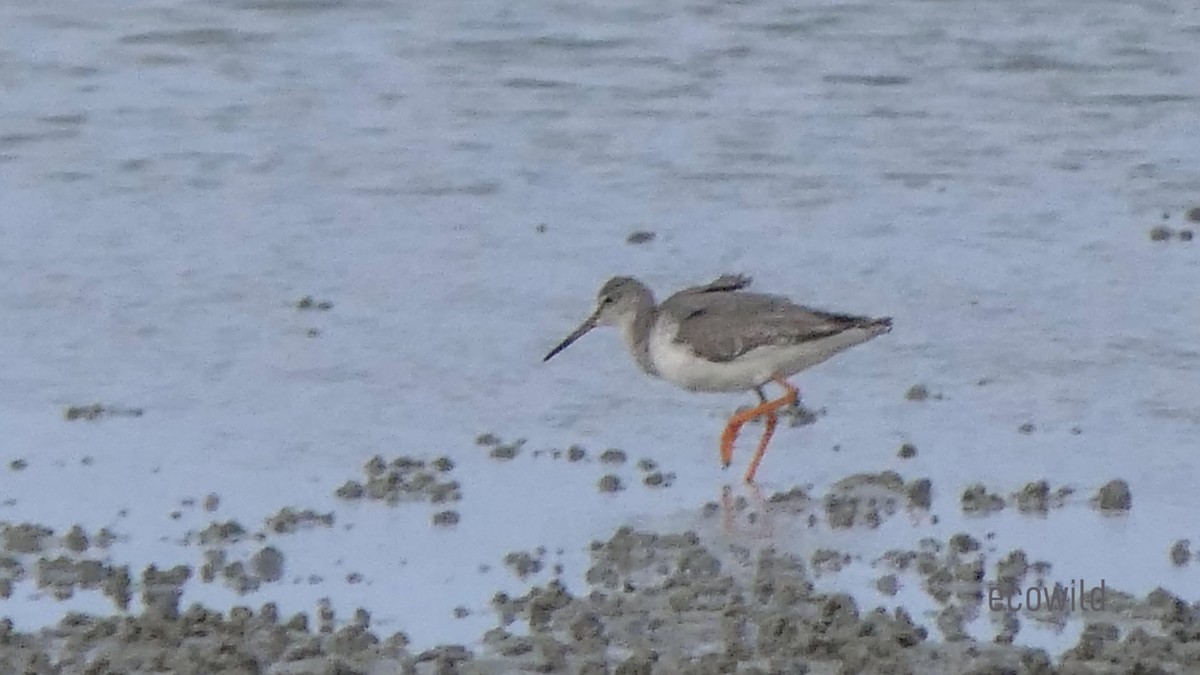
[0,458,1200,675]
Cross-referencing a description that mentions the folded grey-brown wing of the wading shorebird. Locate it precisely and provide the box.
[664,293,875,362]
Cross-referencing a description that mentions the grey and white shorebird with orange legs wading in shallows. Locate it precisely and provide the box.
[542,274,892,483]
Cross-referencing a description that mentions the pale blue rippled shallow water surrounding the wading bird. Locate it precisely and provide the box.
[0,0,1200,641]
